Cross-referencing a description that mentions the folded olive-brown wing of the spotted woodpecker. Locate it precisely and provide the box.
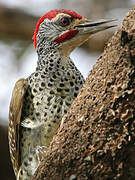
[8,79,28,175]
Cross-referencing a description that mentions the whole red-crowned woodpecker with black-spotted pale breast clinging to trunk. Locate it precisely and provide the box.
[8,9,113,180]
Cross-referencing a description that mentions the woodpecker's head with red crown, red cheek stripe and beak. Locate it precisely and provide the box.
[33,9,113,55]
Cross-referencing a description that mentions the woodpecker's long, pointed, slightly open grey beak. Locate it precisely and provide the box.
[74,19,117,35]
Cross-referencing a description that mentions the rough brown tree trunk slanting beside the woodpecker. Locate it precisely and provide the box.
[33,8,135,180]
